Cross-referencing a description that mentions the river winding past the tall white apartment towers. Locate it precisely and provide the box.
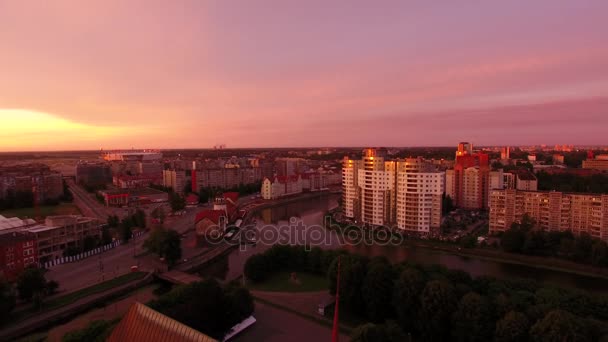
[201,195,608,292]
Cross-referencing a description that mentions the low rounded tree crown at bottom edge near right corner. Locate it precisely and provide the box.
[530,310,589,342]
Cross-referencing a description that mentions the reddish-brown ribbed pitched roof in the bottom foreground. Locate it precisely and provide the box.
[107,303,217,342]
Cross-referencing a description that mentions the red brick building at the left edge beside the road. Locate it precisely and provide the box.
[0,232,38,281]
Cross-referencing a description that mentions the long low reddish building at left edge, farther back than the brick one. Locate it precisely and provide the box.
[0,164,63,203]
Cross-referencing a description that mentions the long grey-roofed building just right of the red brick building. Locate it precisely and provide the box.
[22,215,101,264]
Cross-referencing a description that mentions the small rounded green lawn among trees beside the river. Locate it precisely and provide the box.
[249,272,329,292]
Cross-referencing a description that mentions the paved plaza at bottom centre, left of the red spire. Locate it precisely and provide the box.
[231,302,350,342]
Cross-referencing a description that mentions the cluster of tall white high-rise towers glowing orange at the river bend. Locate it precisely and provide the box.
[342,146,442,233]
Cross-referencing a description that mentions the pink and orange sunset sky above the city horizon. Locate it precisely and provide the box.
[0,0,608,151]
